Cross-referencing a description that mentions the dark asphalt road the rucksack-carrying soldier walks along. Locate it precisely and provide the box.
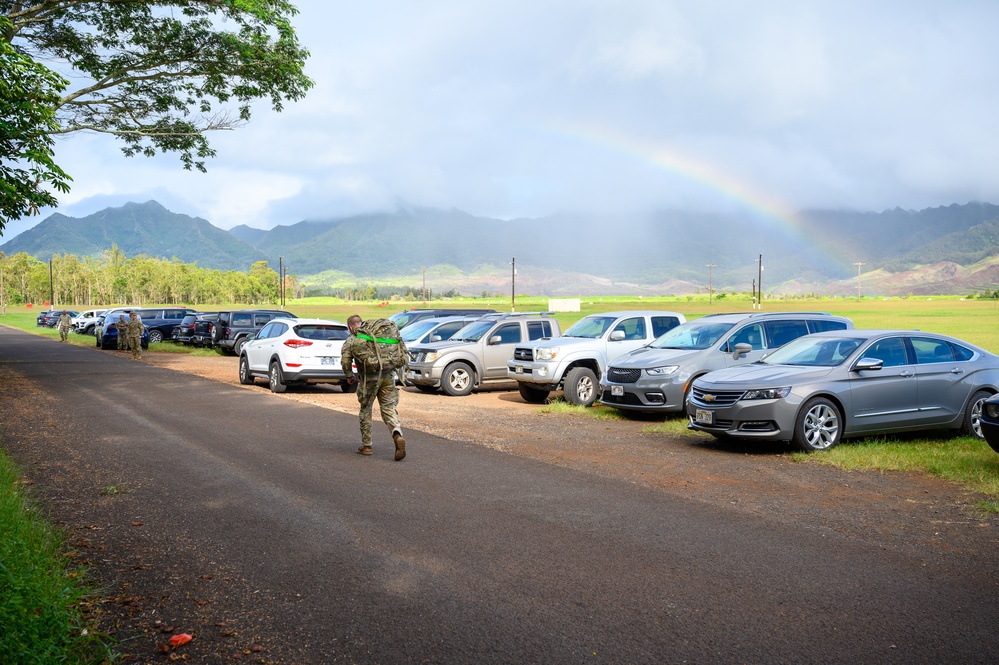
[0,328,999,663]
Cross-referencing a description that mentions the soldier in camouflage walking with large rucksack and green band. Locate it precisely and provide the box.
[340,314,406,462]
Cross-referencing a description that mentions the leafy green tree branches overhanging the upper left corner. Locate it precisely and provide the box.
[0,0,313,232]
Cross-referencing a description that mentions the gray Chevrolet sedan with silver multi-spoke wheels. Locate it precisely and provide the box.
[687,330,999,450]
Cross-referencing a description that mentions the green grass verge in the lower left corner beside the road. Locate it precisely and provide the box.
[0,452,113,665]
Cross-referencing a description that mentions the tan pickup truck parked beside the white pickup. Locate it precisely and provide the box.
[406,312,561,397]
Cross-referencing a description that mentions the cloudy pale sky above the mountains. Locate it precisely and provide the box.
[4,0,999,241]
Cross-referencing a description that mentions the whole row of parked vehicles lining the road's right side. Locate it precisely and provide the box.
[60,307,999,452]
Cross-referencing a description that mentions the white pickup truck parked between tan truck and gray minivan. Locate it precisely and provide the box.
[507,310,687,406]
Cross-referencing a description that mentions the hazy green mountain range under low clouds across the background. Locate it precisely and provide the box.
[0,201,999,295]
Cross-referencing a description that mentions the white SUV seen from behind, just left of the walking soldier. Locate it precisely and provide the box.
[239,318,357,393]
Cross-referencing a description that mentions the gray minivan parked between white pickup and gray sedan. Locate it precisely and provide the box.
[600,312,853,413]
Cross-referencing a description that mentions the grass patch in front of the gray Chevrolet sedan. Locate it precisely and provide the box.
[792,436,999,512]
